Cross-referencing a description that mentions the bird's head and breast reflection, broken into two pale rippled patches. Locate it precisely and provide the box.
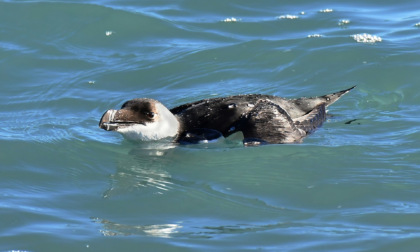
[95,142,182,238]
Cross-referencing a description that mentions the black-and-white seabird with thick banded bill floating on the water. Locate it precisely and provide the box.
[99,86,355,146]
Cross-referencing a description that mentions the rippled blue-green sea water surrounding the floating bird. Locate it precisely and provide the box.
[0,0,420,251]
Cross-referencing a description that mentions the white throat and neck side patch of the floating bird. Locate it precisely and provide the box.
[117,102,179,141]
